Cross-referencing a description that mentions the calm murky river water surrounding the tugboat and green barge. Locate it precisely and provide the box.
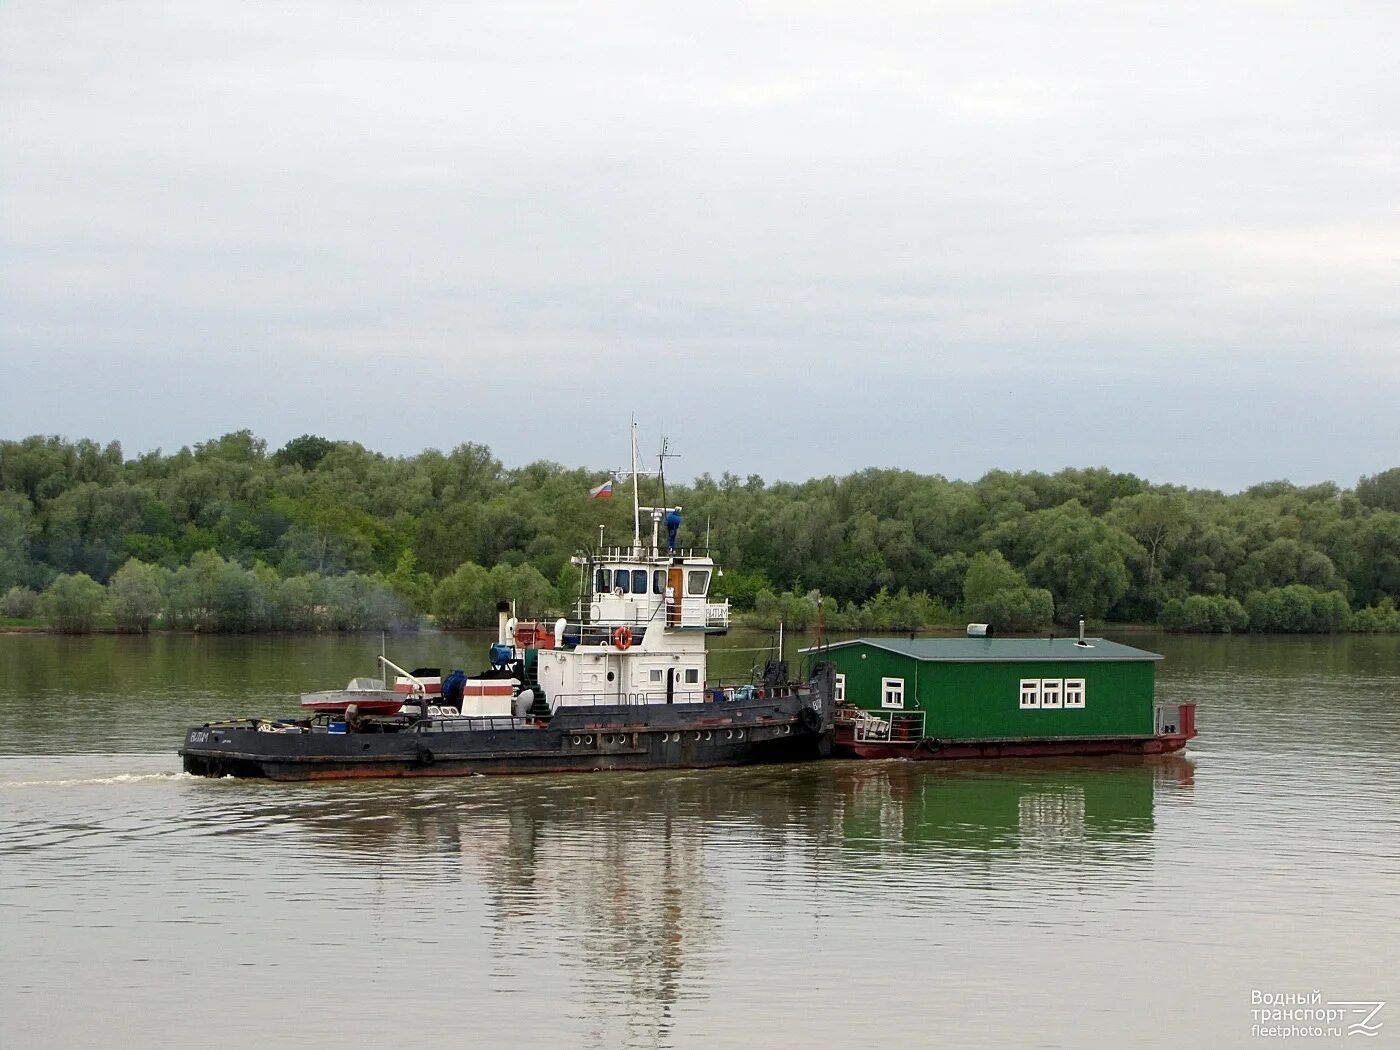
[0,633,1400,1050]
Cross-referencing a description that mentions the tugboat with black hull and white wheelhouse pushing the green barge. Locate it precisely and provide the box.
[179,424,836,780]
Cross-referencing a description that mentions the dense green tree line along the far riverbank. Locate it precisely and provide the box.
[0,431,1400,631]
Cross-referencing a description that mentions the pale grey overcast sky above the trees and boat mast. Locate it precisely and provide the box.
[0,0,1400,490]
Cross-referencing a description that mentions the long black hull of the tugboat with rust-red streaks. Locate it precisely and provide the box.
[179,693,832,780]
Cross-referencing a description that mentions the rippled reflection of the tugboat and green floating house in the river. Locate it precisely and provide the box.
[246,756,1193,1046]
